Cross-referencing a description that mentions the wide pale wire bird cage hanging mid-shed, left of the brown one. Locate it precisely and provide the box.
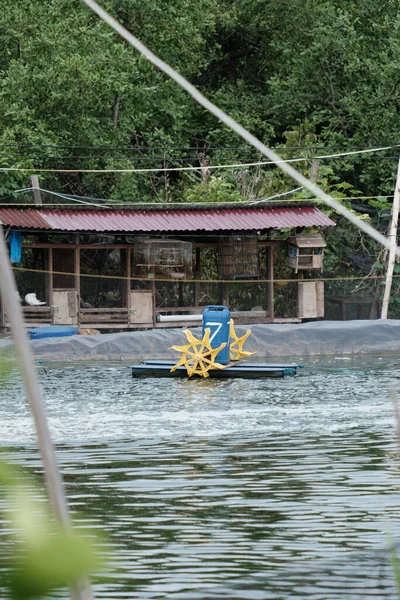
[133,239,192,279]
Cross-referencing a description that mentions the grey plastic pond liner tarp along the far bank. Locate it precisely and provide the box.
[0,320,400,361]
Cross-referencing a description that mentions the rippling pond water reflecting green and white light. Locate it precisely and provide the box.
[0,357,400,600]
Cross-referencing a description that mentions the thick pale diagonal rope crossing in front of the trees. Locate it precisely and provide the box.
[83,0,400,257]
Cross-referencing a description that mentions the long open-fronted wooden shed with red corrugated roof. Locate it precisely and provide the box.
[0,198,334,330]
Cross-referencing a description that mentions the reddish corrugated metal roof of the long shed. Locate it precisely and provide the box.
[0,206,335,233]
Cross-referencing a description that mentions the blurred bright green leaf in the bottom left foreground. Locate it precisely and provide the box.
[0,463,108,600]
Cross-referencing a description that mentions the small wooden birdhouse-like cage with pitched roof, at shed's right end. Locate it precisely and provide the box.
[288,233,326,273]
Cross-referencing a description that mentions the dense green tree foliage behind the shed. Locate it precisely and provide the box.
[0,0,400,201]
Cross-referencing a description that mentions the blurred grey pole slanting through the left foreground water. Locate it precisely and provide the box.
[0,223,93,600]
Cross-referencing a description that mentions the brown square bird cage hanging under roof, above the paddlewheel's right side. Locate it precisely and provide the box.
[218,236,260,279]
